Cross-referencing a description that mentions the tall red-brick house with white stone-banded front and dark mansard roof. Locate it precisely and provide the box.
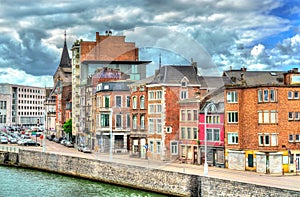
[146,63,200,160]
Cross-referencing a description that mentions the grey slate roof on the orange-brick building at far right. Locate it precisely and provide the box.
[223,69,286,86]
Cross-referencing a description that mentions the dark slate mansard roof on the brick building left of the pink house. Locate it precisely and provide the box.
[150,65,200,85]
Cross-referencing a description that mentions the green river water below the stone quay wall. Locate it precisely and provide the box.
[0,166,168,197]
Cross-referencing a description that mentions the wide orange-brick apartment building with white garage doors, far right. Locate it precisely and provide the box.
[224,68,300,174]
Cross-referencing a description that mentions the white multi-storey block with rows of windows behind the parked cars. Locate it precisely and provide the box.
[0,83,45,127]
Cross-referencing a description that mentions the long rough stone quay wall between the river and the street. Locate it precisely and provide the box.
[0,149,300,197]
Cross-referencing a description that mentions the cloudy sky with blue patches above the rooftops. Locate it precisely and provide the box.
[0,0,300,87]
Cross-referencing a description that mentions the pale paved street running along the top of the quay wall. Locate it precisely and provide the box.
[19,140,300,192]
